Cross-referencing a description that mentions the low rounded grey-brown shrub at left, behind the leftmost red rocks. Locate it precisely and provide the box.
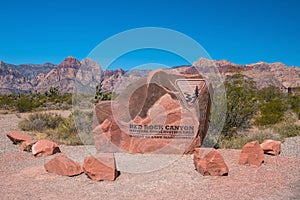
[19,113,63,131]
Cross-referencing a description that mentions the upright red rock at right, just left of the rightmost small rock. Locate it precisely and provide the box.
[239,141,265,167]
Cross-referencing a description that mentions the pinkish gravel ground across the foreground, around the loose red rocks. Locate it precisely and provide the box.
[0,111,300,199]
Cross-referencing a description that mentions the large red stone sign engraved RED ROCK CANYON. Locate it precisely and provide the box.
[93,69,211,154]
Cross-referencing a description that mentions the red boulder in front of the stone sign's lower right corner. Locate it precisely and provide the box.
[194,148,228,176]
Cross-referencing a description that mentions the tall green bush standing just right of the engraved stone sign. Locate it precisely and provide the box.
[222,74,258,138]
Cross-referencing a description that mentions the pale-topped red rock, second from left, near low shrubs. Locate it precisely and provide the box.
[32,140,60,157]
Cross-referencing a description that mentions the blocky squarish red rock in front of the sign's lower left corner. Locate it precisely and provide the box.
[83,153,117,181]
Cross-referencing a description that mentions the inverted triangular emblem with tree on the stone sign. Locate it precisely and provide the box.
[176,79,205,107]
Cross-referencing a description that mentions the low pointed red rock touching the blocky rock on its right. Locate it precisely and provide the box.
[44,154,83,176]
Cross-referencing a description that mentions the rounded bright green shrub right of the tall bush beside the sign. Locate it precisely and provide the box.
[255,98,288,126]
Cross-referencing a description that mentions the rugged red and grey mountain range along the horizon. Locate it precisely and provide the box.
[0,56,300,94]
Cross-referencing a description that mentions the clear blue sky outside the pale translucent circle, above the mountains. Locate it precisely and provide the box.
[0,0,300,66]
